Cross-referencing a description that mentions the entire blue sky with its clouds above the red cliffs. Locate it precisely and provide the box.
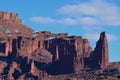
[0,0,120,61]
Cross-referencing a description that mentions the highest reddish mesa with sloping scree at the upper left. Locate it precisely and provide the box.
[0,11,33,35]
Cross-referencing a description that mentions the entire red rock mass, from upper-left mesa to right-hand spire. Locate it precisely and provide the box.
[0,12,109,80]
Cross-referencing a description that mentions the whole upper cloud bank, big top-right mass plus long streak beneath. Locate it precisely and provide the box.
[30,0,120,31]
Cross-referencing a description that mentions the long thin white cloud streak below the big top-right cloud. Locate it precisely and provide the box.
[30,16,100,27]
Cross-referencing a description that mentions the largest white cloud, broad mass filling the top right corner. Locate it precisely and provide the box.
[58,0,120,26]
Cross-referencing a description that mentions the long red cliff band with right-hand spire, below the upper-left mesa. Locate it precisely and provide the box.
[1,32,109,78]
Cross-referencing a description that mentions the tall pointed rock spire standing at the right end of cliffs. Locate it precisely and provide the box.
[91,32,109,68]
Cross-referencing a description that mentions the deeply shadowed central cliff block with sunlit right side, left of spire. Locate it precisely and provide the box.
[45,36,92,73]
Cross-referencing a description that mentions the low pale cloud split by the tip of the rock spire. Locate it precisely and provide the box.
[84,34,119,41]
